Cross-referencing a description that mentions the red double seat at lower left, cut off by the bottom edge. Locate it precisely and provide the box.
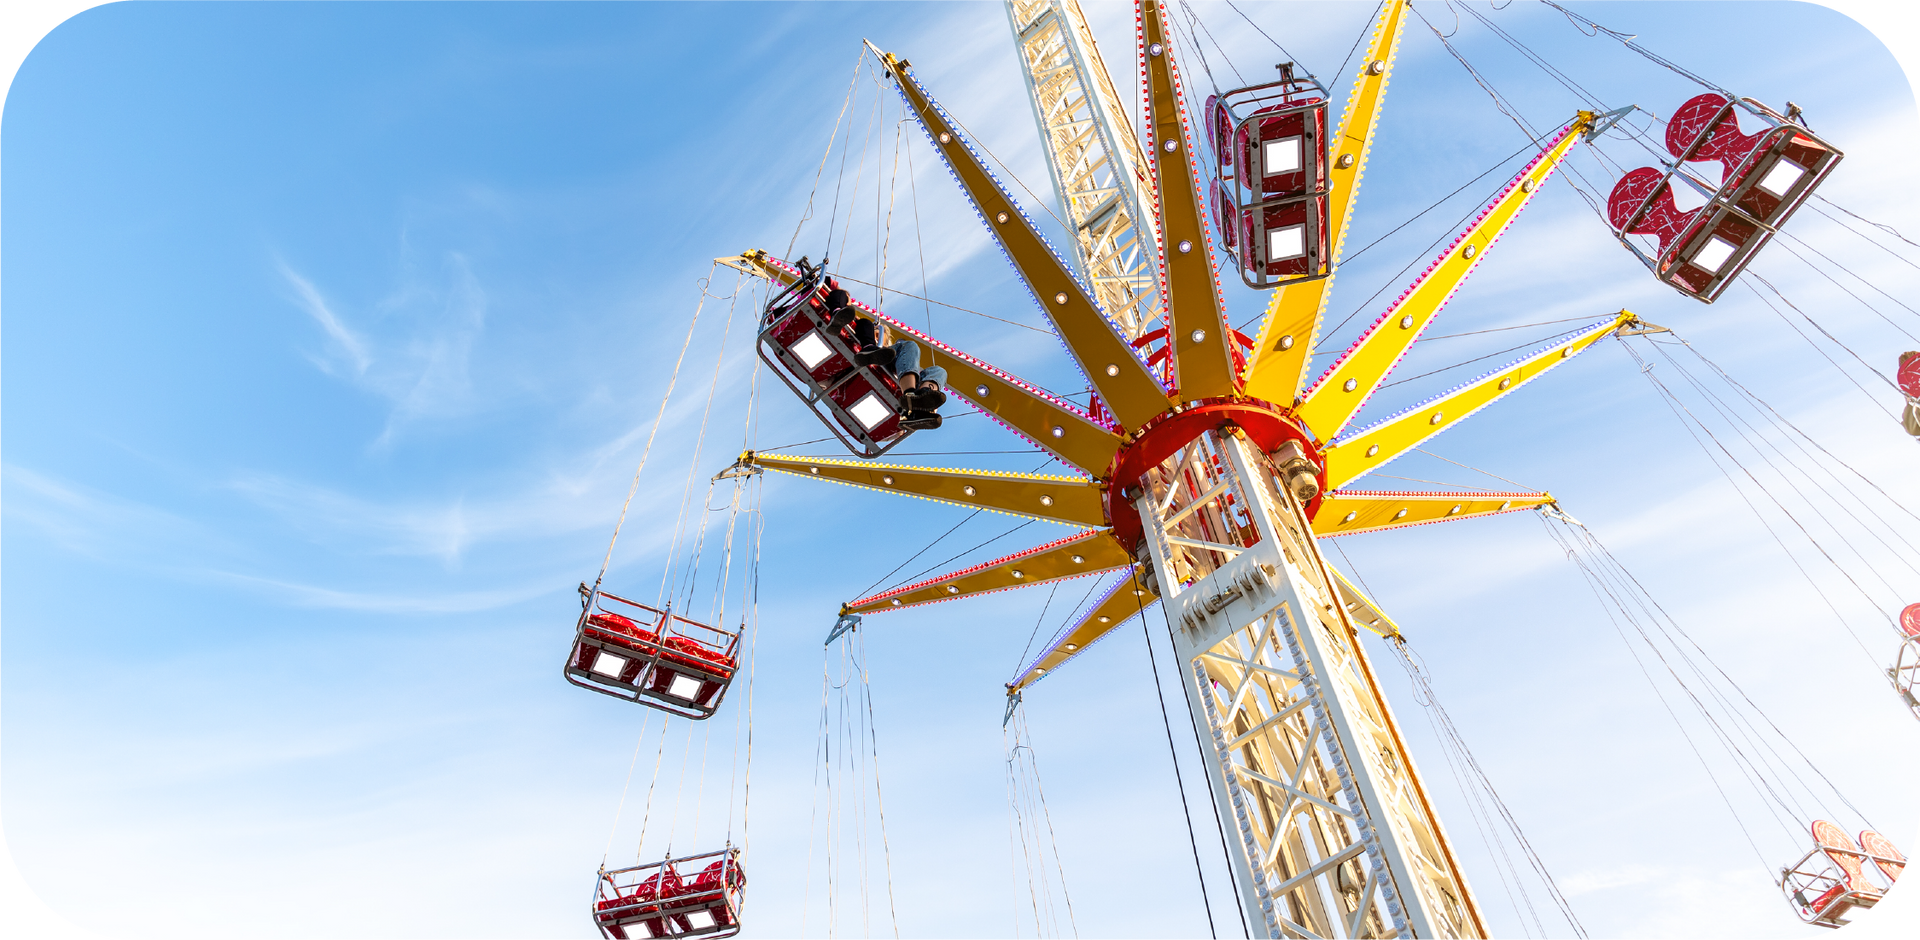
[593,848,747,940]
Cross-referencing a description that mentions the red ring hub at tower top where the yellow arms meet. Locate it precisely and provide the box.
[1106,399,1327,554]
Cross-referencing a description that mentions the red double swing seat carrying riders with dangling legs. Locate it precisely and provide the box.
[760,259,914,458]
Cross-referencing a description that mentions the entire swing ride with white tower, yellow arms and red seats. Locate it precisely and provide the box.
[564,0,1920,940]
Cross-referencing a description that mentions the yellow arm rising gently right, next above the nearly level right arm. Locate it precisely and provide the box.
[1321,311,1640,491]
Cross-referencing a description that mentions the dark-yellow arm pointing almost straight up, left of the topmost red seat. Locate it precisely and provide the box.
[1140,0,1240,401]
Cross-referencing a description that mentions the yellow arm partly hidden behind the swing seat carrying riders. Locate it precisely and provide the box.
[716,249,1121,478]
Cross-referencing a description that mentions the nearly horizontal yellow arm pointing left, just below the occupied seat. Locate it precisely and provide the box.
[739,451,1106,528]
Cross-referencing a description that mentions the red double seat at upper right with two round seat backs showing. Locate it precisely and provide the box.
[1607,92,1843,303]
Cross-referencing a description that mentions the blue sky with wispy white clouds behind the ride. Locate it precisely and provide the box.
[0,0,1920,938]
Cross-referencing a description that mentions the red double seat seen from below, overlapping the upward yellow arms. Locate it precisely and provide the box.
[1206,65,1332,288]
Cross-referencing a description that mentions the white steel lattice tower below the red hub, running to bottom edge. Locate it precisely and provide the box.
[1116,432,1486,940]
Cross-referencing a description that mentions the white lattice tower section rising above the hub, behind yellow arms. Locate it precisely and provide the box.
[1006,0,1160,340]
